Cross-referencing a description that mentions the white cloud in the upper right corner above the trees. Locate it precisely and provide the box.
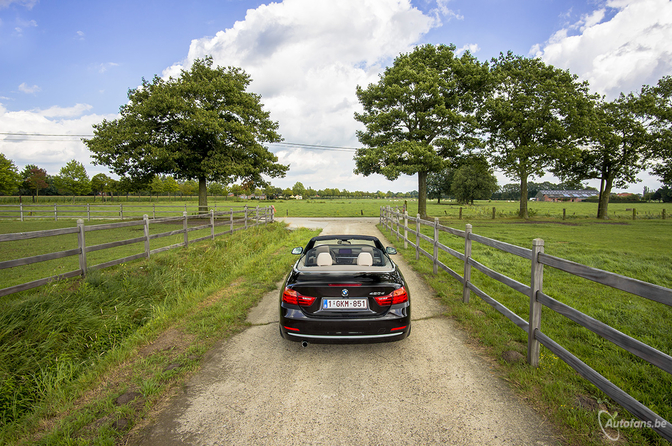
[531,0,672,99]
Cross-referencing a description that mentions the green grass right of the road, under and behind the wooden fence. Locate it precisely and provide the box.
[381,220,672,445]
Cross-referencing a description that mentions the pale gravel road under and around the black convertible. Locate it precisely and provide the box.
[133,218,559,446]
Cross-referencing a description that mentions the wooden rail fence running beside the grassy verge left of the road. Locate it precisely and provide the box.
[0,206,273,297]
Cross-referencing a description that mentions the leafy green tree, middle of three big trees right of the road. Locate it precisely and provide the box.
[480,52,592,218]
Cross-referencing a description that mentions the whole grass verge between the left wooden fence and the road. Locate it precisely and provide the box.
[0,224,314,444]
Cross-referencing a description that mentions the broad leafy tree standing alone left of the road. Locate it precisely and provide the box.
[85,57,289,211]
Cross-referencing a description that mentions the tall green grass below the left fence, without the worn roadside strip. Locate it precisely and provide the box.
[0,225,312,439]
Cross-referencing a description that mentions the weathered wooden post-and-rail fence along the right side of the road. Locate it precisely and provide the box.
[380,207,672,442]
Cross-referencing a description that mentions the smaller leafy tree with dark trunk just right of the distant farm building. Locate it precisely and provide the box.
[560,94,653,219]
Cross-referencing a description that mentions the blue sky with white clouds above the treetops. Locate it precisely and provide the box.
[0,0,672,192]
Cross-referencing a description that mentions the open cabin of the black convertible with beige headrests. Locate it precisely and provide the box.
[297,240,391,270]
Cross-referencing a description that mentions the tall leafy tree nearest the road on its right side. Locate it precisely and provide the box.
[355,45,488,218]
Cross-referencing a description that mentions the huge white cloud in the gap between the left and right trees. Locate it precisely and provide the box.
[163,0,436,190]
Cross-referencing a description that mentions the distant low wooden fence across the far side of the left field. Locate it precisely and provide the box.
[0,203,255,221]
